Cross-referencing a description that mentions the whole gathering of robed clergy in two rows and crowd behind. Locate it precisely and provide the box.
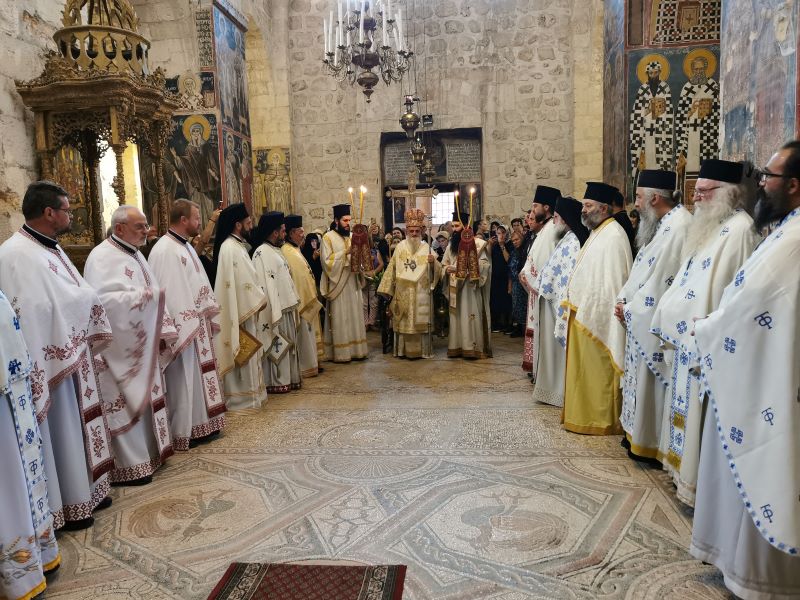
[0,137,800,599]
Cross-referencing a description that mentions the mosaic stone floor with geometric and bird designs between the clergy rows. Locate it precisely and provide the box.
[47,334,730,600]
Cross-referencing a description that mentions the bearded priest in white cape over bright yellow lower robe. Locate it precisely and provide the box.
[562,181,632,435]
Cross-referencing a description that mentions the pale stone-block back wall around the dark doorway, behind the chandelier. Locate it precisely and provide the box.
[289,0,602,230]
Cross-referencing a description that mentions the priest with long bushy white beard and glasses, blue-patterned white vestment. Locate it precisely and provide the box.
[650,159,759,506]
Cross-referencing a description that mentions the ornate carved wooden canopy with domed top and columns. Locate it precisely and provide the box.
[17,0,178,262]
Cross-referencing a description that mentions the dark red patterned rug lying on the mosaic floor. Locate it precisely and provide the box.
[208,563,406,600]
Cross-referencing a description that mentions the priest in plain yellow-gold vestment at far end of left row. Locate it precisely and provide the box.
[281,215,325,378]
